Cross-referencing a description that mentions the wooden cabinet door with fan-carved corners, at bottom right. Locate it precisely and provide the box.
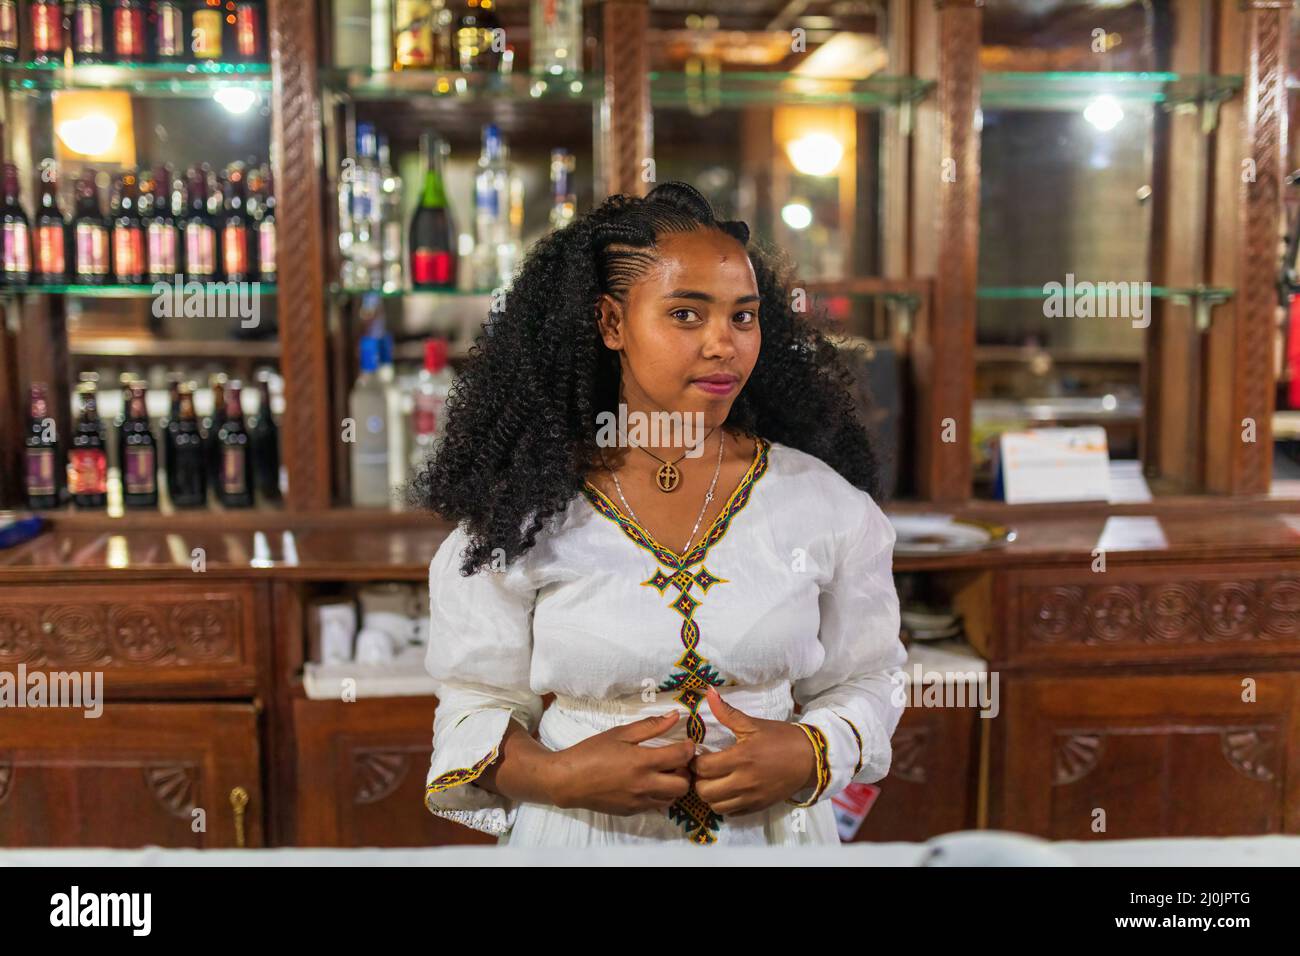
[989,667,1300,840]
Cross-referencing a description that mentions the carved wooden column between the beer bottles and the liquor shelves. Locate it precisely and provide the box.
[268,0,330,511]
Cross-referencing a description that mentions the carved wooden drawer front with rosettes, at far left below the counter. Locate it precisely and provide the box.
[0,584,256,696]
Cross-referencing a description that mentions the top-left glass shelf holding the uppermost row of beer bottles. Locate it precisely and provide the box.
[0,62,270,96]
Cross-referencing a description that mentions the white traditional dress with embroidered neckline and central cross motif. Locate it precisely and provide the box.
[425,438,906,847]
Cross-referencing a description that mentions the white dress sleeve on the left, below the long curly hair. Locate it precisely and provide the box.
[424,527,542,834]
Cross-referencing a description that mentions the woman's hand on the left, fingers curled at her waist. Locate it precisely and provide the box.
[547,711,696,817]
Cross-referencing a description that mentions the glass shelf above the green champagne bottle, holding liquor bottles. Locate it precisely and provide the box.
[321,68,605,103]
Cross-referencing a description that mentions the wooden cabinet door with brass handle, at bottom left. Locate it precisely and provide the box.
[0,701,264,849]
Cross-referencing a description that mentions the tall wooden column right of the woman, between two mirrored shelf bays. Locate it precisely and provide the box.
[911,0,983,502]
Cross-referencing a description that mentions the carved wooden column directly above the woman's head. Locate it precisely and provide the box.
[602,0,654,195]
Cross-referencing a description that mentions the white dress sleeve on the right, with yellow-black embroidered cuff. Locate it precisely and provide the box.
[790,497,907,806]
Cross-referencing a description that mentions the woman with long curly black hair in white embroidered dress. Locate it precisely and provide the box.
[417,183,906,845]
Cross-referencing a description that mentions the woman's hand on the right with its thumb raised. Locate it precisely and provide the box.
[690,687,816,817]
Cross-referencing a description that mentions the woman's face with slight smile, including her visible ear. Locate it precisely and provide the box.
[601,228,762,428]
